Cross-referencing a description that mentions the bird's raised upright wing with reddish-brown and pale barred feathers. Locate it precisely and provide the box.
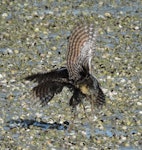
[67,24,96,81]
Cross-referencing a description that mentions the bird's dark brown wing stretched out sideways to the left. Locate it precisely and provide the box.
[25,67,73,105]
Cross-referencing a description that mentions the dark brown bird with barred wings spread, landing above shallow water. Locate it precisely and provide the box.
[25,24,105,108]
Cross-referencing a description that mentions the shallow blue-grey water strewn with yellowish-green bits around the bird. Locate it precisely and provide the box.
[0,0,142,150]
